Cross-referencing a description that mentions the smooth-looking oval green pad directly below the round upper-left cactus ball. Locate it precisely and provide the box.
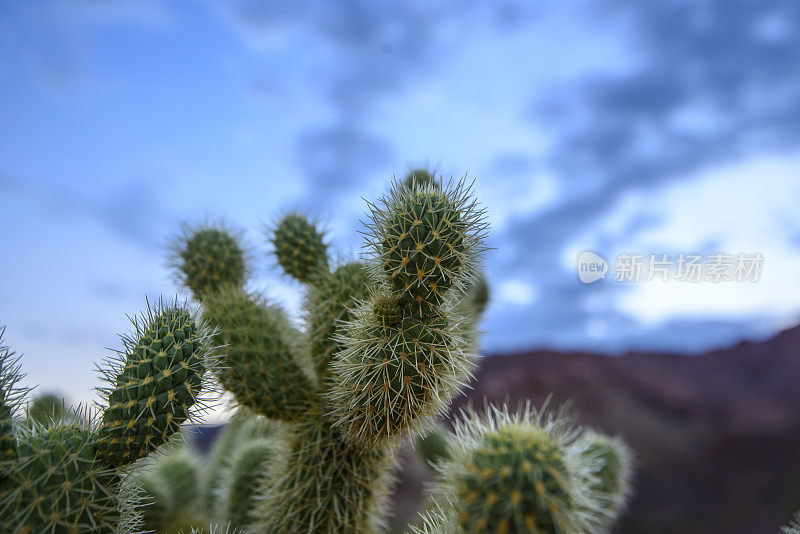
[205,290,316,421]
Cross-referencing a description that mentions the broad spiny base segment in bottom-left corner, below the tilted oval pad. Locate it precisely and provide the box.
[0,427,124,534]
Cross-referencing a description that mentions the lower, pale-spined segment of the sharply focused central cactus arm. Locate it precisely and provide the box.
[329,294,472,444]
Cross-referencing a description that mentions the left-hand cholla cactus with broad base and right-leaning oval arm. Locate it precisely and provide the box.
[0,303,216,533]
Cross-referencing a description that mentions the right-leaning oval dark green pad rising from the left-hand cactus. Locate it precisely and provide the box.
[97,302,209,466]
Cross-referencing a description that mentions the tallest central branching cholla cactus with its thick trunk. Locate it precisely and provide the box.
[173,175,486,533]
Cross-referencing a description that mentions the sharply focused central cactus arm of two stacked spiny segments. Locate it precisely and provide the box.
[328,182,485,444]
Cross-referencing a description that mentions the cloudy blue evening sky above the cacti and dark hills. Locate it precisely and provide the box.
[0,0,800,414]
